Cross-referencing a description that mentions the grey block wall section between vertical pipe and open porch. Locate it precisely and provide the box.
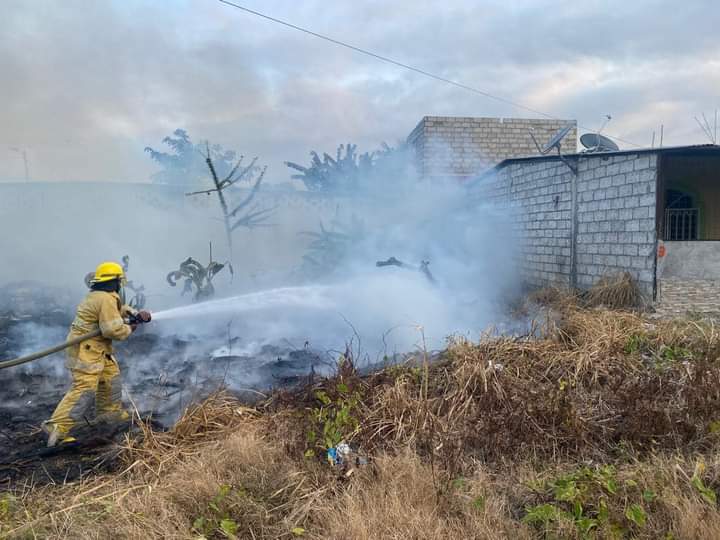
[576,153,657,298]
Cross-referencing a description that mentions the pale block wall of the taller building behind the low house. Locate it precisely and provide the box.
[407,116,577,178]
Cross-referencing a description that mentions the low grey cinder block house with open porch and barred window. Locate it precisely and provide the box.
[467,145,720,313]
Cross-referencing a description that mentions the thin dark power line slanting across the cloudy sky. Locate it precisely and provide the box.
[218,0,641,147]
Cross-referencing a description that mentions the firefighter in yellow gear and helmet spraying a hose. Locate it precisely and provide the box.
[43,262,150,447]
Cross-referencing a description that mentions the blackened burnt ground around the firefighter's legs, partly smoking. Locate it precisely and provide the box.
[0,284,331,490]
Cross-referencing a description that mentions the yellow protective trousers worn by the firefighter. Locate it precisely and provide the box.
[47,354,127,434]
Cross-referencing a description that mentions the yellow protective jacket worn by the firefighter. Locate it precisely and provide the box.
[65,291,134,373]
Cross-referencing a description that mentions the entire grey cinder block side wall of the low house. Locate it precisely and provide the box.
[469,153,657,298]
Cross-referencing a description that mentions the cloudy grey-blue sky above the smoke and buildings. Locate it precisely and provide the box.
[0,0,720,182]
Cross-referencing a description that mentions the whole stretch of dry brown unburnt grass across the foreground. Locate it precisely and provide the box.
[0,305,720,539]
